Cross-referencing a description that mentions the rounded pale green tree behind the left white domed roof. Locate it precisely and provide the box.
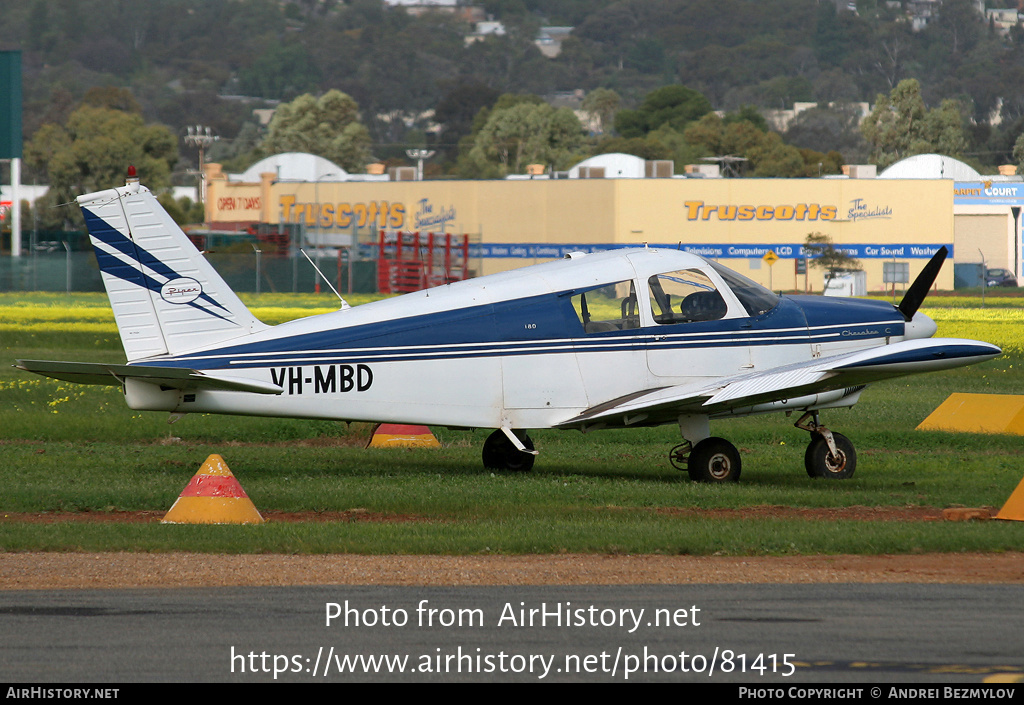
[259,90,371,171]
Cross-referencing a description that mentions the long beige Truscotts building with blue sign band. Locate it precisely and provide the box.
[206,154,1024,293]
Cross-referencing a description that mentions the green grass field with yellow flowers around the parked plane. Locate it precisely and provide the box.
[0,293,1024,555]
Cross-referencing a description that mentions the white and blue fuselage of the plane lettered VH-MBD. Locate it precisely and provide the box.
[126,250,917,428]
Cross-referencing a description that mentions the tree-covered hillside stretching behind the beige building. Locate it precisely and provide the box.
[6,0,1024,225]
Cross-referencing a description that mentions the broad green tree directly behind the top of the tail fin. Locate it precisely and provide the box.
[25,106,178,223]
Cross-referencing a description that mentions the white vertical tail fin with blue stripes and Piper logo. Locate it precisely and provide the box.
[78,169,267,362]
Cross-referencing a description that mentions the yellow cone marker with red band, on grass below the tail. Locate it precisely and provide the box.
[161,453,263,524]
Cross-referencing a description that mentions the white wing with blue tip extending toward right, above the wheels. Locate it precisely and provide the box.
[557,338,1002,428]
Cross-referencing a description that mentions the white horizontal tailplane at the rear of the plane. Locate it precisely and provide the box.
[14,360,284,395]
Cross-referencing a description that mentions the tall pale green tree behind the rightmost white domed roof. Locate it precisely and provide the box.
[860,78,967,167]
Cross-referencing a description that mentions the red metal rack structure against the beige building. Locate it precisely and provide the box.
[377,231,469,294]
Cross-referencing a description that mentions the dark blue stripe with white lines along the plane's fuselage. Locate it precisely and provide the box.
[128,292,902,369]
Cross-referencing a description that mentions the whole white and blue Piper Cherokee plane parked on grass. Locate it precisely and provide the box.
[18,172,1001,482]
